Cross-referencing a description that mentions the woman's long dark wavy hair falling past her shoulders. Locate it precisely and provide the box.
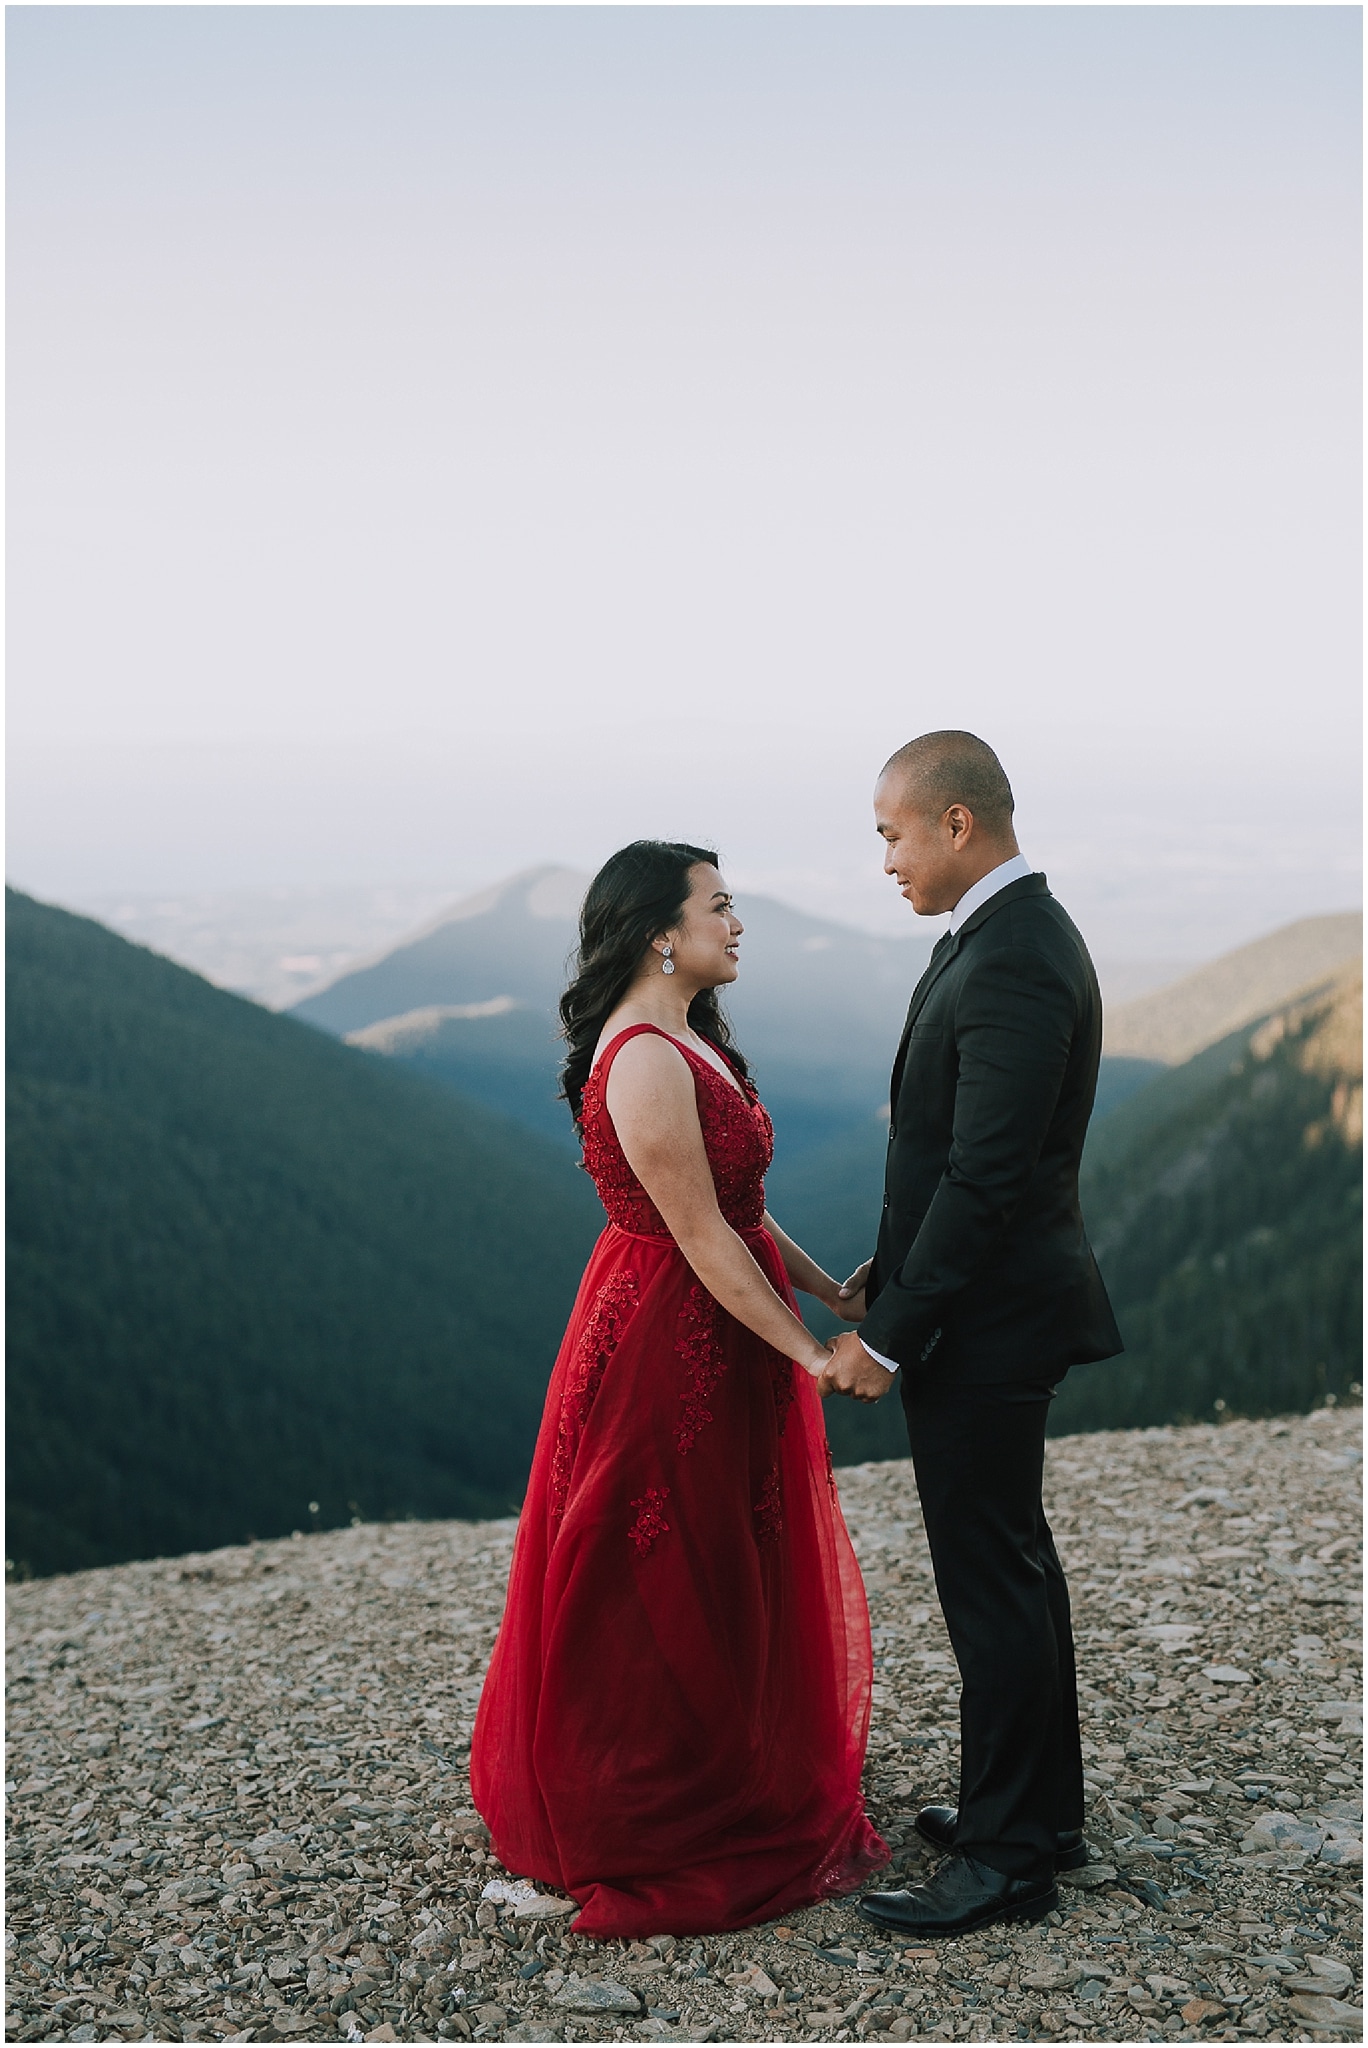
[561,840,750,1128]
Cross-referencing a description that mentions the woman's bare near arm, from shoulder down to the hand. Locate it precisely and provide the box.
[606,1034,831,1376]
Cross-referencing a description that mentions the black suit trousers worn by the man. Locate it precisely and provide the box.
[901,1370,1083,1878]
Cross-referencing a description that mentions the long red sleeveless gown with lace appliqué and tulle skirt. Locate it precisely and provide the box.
[471,1024,889,1937]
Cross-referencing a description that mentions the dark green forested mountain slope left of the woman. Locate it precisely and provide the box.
[8,893,602,1571]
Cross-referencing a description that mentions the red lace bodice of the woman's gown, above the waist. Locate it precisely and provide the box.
[580,1024,774,1237]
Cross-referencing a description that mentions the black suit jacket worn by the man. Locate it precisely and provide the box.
[860,874,1122,1380]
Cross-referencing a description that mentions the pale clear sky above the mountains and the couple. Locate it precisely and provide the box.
[8,6,1360,958]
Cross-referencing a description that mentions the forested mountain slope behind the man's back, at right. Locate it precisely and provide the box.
[1055,967,1364,1430]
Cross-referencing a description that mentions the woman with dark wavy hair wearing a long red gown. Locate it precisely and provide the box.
[471,840,889,1937]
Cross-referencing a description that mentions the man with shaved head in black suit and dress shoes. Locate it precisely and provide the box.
[823,731,1122,1935]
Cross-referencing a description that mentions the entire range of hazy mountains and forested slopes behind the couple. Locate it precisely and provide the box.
[8,888,1362,1571]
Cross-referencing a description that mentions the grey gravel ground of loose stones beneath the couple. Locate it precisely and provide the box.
[6,1411,1362,2042]
